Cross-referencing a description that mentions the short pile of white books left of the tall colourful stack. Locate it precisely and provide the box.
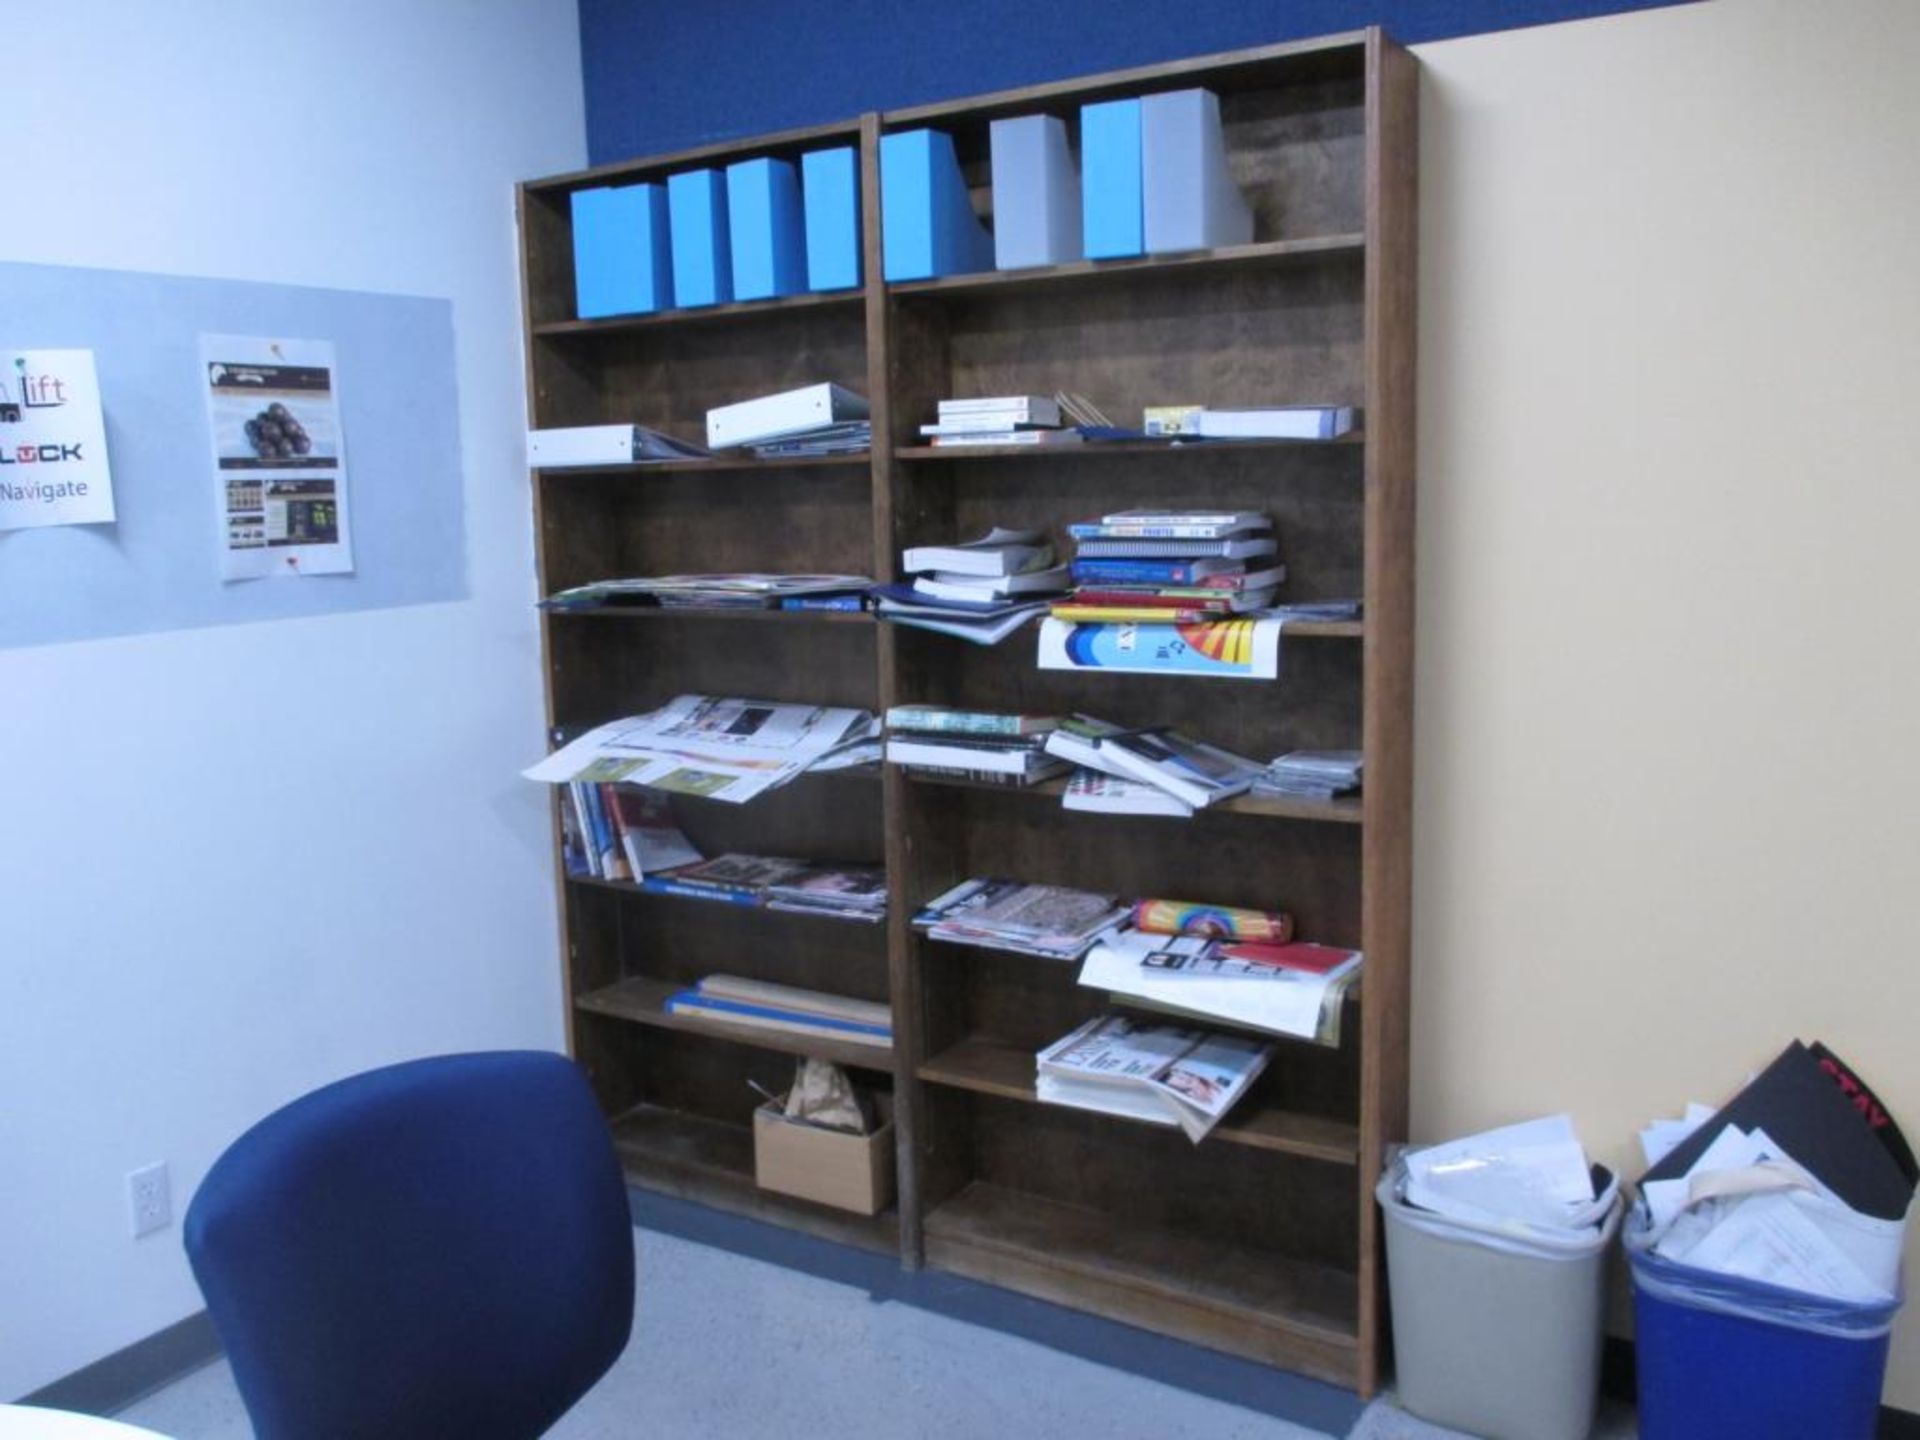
[874,526,1068,645]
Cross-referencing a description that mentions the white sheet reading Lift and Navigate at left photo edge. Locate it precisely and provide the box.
[0,349,113,530]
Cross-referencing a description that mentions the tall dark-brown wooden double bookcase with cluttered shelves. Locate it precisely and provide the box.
[518,31,1417,1394]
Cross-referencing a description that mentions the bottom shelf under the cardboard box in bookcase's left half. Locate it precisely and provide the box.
[611,1104,900,1254]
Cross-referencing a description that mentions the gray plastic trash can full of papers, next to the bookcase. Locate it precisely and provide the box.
[1375,1162,1620,1440]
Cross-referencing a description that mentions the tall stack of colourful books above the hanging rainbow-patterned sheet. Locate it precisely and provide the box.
[1052,511,1286,624]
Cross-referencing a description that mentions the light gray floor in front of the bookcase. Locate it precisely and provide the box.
[121,1231,1632,1440]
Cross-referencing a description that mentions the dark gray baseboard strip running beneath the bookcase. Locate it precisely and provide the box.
[630,1190,1365,1436]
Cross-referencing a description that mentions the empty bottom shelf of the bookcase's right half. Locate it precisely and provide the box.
[925,1181,1357,1380]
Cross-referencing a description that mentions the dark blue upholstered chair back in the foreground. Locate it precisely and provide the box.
[186,1050,634,1440]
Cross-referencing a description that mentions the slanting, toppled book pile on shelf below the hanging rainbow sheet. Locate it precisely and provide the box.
[1046,716,1265,816]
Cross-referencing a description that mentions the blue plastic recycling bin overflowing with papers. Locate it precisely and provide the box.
[1626,1227,1901,1440]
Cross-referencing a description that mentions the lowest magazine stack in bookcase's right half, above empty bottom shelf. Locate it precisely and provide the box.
[1033,1016,1273,1144]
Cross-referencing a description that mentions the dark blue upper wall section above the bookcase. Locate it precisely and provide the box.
[580,0,1684,165]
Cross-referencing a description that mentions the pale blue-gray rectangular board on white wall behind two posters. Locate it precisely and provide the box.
[0,265,467,647]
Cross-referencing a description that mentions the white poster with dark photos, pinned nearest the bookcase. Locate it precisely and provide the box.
[200,334,353,580]
